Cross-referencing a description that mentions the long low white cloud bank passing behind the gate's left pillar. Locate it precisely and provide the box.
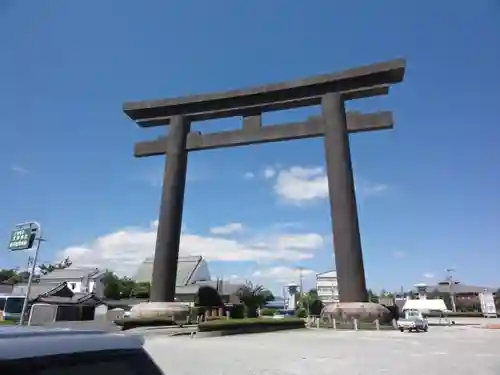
[59,222,323,275]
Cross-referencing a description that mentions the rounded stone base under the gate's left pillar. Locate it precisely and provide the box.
[130,302,190,324]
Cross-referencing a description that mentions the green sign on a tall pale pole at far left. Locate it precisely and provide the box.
[9,221,44,325]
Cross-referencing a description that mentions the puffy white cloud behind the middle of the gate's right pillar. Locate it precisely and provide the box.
[268,166,388,204]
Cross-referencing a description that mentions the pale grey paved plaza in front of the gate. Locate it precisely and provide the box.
[146,321,500,375]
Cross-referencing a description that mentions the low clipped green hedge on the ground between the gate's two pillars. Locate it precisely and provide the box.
[198,318,305,332]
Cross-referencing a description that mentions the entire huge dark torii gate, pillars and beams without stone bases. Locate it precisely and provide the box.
[123,59,405,302]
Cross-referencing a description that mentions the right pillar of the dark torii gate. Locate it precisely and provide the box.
[321,93,368,302]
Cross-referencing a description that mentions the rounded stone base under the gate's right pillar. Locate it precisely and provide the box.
[321,302,391,322]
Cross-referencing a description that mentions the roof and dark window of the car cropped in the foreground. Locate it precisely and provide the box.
[0,326,163,375]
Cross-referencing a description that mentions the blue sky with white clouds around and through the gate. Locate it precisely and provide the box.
[0,0,500,290]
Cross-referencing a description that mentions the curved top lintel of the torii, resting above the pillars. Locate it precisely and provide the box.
[123,59,406,127]
